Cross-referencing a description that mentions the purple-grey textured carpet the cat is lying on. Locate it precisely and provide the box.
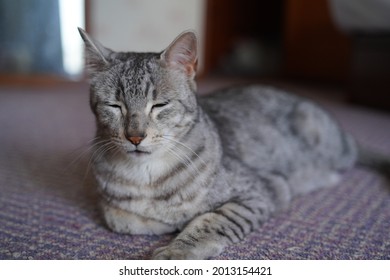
[0,82,390,259]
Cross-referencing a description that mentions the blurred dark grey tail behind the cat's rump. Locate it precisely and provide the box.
[357,146,390,179]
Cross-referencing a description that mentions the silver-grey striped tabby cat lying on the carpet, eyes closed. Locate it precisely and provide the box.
[79,29,388,259]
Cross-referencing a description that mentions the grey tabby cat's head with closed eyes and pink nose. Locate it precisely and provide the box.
[79,29,198,159]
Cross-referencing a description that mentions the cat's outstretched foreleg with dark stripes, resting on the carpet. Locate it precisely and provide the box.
[153,198,276,259]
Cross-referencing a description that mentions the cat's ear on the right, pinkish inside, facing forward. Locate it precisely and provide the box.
[161,31,198,78]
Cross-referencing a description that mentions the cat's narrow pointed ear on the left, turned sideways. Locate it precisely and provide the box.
[78,27,112,72]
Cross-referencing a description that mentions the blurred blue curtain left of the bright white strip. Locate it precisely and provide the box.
[0,0,64,74]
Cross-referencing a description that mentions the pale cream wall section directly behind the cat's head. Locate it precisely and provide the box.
[90,0,205,65]
